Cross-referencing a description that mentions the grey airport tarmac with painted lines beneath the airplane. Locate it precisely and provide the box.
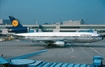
[0,39,105,64]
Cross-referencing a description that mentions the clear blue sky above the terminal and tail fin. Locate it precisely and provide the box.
[0,0,105,24]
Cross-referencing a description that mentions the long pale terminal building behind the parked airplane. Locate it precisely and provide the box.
[0,19,105,35]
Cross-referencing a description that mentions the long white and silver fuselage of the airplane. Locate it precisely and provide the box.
[15,32,102,43]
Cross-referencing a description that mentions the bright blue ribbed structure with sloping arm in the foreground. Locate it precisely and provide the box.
[0,50,105,67]
